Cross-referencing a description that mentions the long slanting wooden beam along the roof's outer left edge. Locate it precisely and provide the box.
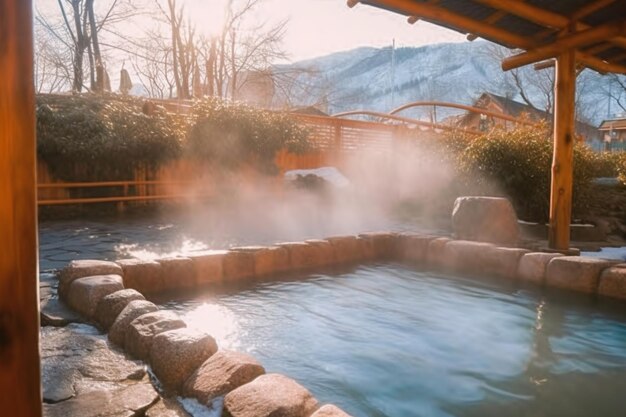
[360,0,535,49]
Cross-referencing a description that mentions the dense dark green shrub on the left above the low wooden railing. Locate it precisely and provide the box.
[37,95,184,181]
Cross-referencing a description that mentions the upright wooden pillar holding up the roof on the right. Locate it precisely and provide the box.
[549,50,576,251]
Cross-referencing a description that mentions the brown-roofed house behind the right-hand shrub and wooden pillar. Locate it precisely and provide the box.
[458,93,602,144]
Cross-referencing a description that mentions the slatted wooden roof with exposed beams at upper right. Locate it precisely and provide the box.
[348,0,626,74]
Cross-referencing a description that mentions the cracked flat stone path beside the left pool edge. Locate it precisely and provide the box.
[40,268,189,417]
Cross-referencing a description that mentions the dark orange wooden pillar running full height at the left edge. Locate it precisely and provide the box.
[0,0,41,417]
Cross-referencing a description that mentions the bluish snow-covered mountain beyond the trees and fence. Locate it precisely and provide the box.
[275,41,617,124]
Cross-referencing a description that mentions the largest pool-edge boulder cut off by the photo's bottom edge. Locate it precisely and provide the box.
[224,374,317,417]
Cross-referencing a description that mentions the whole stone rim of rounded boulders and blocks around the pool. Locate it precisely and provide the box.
[52,232,626,417]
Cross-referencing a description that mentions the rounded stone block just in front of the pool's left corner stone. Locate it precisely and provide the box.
[67,275,124,318]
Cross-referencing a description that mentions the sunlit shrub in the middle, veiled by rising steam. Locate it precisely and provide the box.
[188,99,308,173]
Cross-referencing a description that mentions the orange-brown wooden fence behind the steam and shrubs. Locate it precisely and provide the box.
[37,112,402,206]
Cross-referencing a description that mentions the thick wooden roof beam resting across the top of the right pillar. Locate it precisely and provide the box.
[502,21,626,71]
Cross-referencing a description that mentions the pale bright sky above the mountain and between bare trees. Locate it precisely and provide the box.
[184,0,465,61]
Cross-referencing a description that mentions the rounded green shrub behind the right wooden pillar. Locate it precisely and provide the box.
[458,122,596,222]
